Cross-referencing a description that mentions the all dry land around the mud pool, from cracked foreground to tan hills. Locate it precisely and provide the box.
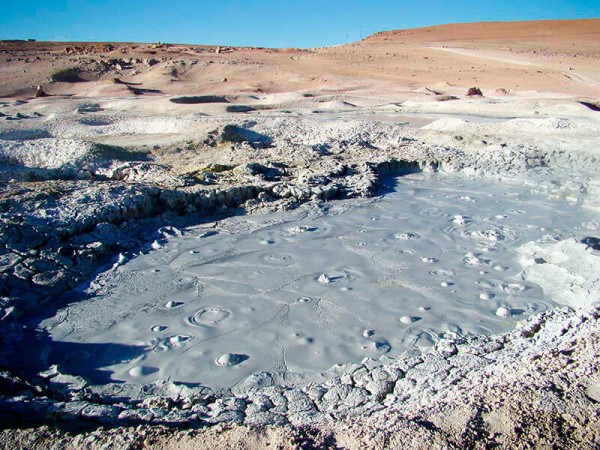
[0,19,600,449]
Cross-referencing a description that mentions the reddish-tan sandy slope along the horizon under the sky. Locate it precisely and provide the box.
[0,19,600,99]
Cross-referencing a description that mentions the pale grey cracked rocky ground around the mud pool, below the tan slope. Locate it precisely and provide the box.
[0,20,600,449]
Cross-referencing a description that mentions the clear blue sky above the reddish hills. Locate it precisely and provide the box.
[0,0,600,47]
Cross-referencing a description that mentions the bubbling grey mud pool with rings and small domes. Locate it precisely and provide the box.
[40,174,594,387]
